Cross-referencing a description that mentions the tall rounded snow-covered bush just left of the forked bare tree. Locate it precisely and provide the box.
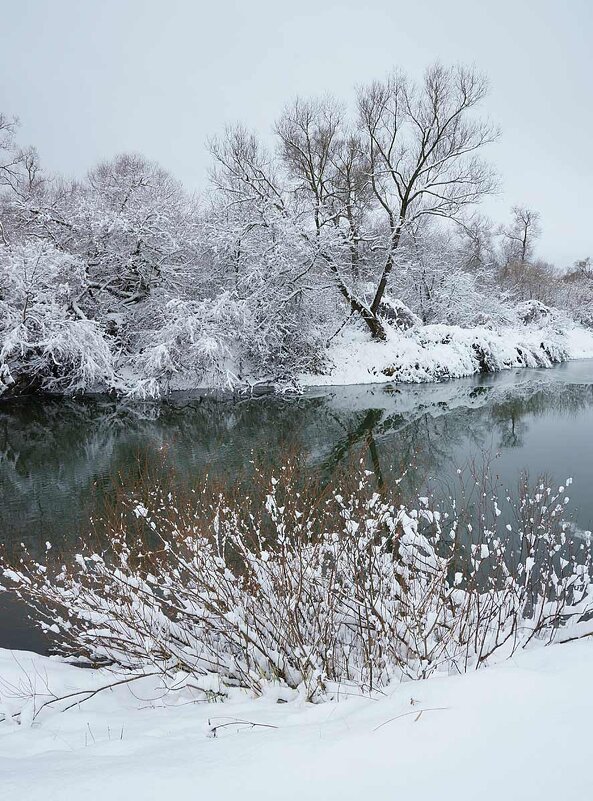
[205,195,338,383]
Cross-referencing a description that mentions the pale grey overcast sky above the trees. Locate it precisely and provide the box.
[0,0,593,266]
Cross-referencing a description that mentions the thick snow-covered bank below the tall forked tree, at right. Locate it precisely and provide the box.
[299,325,593,386]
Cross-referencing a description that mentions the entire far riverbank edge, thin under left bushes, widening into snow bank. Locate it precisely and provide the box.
[0,324,593,405]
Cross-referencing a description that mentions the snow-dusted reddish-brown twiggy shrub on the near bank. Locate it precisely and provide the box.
[2,465,593,700]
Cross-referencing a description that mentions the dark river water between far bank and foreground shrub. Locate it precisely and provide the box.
[0,360,593,649]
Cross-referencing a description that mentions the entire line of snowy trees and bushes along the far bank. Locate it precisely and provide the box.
[0,65,593,395]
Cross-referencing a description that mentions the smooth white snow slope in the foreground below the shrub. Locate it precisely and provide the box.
[0,638,593,801]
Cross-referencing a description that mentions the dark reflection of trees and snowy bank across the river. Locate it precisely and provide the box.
[0,382,593,544]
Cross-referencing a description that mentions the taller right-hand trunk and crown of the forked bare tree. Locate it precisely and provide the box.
[358,64,498,336]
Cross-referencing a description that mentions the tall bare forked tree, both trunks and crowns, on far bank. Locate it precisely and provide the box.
[276,64,498,338]
